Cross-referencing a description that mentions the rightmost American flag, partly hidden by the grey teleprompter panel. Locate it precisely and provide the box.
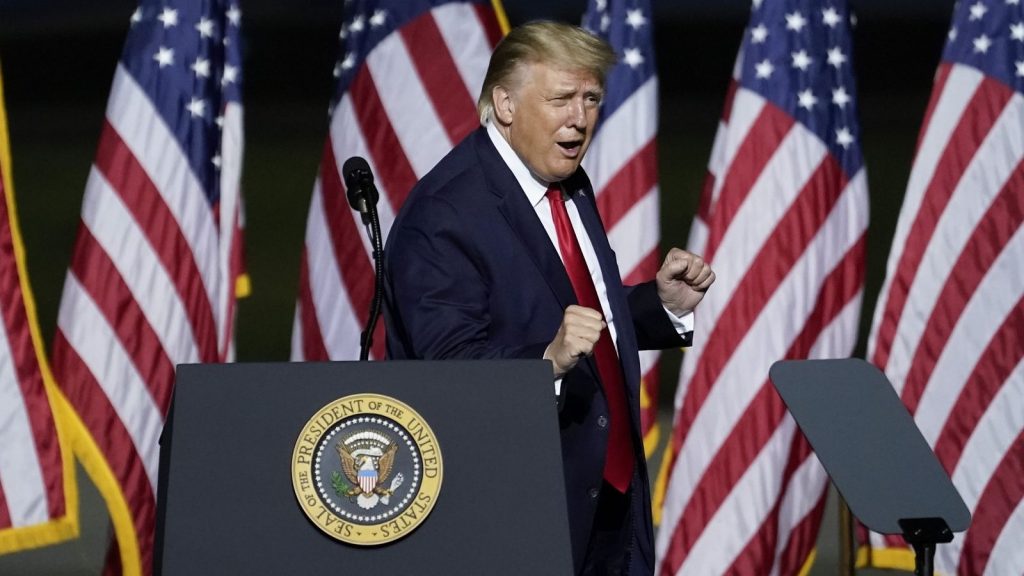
[868,0,1024,574]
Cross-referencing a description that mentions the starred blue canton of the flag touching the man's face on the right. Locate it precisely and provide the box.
[583,0,655,123]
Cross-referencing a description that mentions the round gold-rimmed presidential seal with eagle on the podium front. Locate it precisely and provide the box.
[292,394,442,545]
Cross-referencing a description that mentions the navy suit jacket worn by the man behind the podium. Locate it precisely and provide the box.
[384,128,689,569]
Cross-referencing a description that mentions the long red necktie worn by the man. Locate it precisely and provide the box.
[548,184,633,493]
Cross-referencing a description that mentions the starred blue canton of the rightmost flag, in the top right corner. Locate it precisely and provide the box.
[942,0,1024,92]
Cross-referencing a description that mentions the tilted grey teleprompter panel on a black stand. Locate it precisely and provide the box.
[769,359,971,576]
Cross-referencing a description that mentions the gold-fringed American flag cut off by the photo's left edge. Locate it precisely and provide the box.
[0,61,78,553]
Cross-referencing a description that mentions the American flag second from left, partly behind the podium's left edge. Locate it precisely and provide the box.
[53,0,244,573]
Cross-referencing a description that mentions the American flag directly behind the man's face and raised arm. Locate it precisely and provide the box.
[583,0,660,456]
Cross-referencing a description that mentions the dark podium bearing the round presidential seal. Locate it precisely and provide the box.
[154,361,572,576]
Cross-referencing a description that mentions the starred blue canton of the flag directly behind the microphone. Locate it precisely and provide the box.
[331,0,490,105]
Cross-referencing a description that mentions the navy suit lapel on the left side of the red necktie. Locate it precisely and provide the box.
[475,128,577,310]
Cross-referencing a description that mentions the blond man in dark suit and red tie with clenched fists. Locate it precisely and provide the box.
[385,23,715,574]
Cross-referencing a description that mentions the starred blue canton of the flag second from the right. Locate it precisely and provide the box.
[739,0,864,177]
